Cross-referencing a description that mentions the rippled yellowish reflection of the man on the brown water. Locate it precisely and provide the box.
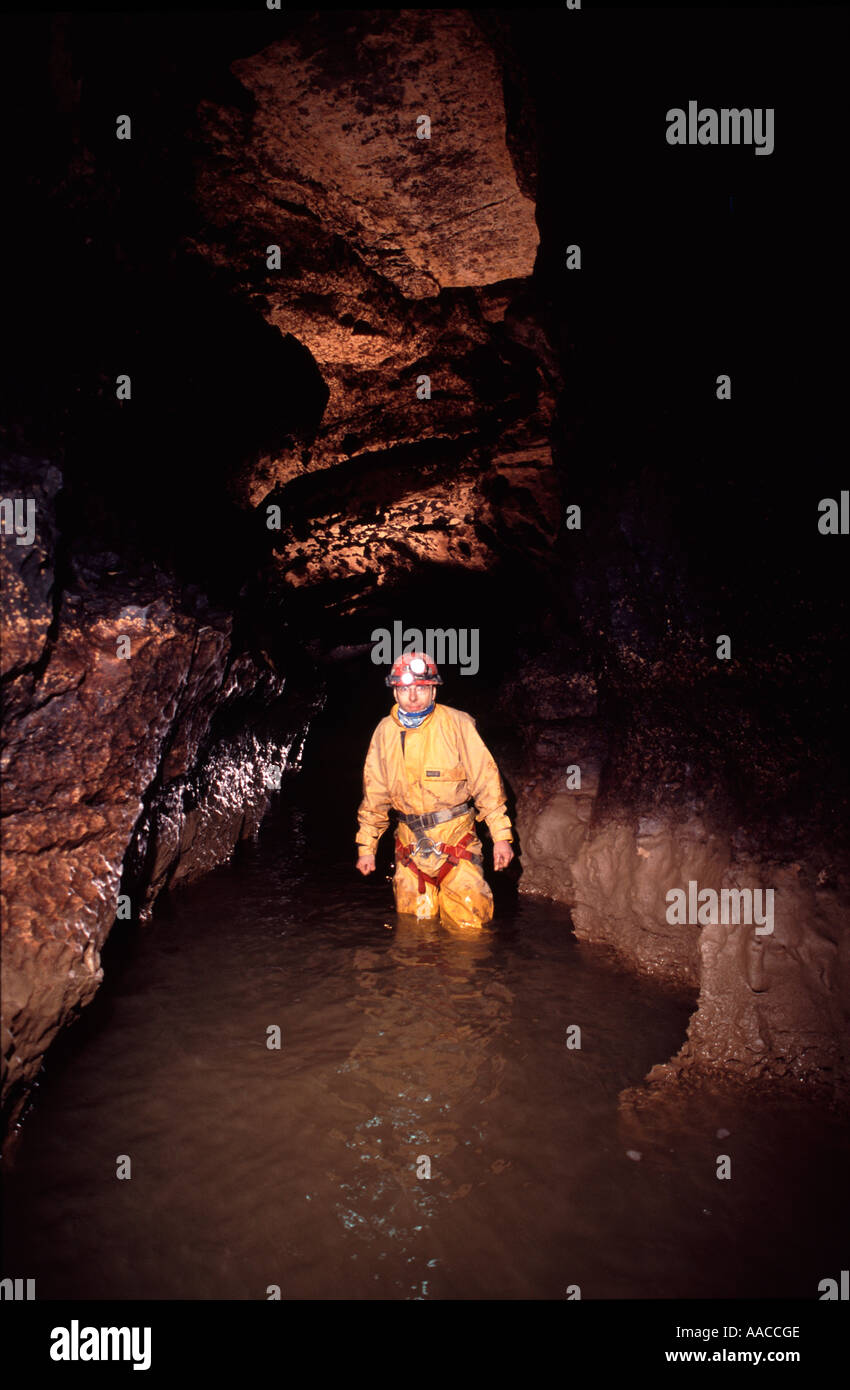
[323,916,513,1298]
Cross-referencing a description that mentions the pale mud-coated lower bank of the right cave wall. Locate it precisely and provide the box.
[517,772,850,1102]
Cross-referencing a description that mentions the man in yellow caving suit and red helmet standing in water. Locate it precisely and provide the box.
[351,652,514,927]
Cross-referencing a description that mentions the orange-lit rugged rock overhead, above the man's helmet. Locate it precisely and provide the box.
[188,10,560,603]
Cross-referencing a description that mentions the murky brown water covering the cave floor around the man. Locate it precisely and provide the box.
[4,774,849,1300]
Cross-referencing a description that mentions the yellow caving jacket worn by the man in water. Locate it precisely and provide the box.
[357,705,514,855]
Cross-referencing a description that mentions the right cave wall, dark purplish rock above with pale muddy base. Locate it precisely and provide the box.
[503,639,850,1105]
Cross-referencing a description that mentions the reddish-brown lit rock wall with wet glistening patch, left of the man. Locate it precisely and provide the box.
[0,456,313,1123]
